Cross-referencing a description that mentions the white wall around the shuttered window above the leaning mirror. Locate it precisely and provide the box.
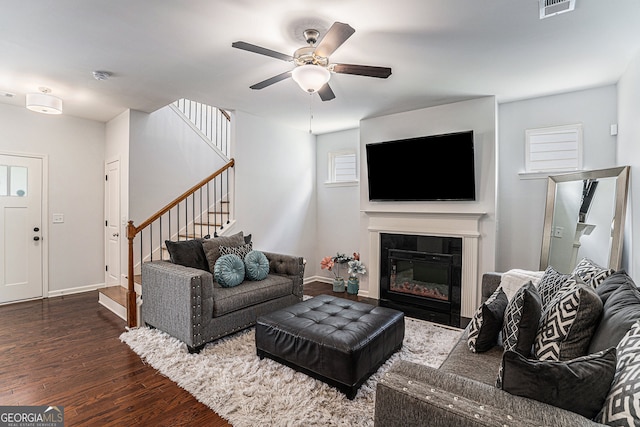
[496,85,616,271]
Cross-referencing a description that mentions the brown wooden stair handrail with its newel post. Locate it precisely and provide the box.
[127,159,235,327]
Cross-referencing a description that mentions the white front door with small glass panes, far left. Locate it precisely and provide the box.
[0,155,43,303]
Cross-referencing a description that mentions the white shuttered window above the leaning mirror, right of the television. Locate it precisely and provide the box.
[525,124,582,173]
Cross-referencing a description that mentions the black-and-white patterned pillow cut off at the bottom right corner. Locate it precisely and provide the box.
[596,323,640,426]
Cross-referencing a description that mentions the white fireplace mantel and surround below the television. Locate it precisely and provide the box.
[363,211,486,317]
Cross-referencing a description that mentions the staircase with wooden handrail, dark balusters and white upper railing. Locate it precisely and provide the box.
[98,99,235,327]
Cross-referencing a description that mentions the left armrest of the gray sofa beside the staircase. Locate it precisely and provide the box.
[141,261,213,347]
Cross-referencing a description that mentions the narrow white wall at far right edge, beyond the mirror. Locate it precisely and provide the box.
[617,54,640,283]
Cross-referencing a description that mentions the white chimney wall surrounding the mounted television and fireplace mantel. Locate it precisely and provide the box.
[360,97,497,304]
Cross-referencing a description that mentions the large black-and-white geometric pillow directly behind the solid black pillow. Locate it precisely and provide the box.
[534,279,602,361]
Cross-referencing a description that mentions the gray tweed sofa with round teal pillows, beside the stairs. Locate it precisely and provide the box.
[141,252,305,352]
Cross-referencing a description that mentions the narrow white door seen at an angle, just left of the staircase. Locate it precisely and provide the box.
[104,160,120,286]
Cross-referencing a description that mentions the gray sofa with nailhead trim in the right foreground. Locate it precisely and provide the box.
[375,273,640,427]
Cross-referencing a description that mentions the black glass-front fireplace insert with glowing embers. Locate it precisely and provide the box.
[380,233,462,327]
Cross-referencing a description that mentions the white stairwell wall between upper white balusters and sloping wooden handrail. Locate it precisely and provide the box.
[129,107,226,225]
